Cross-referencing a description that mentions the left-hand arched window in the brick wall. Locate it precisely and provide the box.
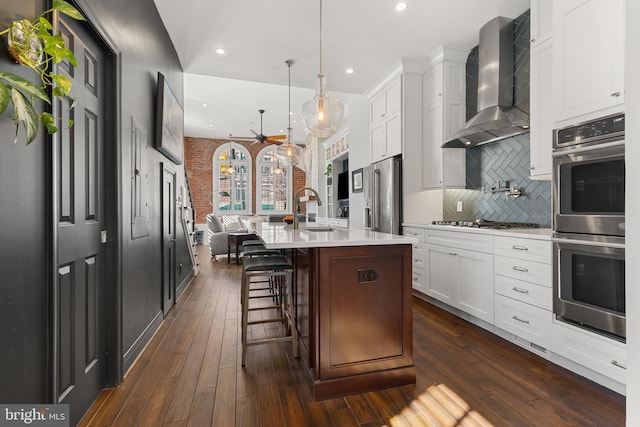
[212,142,252,214]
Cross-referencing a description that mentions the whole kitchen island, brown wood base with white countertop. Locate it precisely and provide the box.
[255,223,417,400]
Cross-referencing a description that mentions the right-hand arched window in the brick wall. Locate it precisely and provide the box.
[256,145,293,214]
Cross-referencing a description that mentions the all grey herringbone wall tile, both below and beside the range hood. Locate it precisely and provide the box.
[443,11,551,227]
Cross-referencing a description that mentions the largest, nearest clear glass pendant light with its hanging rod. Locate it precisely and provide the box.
[302,0,344,138]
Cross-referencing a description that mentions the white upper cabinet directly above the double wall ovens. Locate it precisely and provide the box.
[553,0,625,127]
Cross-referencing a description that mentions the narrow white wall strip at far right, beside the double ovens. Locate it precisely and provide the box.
[625,0,640,426]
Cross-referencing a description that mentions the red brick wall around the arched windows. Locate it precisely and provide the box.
[184,137,307,224]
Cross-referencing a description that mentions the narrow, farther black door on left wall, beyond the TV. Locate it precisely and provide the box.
[161,163,176,315]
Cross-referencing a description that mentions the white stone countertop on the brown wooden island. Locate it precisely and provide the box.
[253,222,418,249]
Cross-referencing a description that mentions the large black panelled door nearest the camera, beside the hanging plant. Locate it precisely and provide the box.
[52,16,108,425]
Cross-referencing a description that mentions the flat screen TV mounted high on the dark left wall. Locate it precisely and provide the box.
[156,72,184,165]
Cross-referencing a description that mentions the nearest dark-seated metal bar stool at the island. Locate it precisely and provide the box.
[240,255,298,366]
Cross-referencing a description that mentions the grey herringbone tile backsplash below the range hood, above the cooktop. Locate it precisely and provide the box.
[443,134,551,227]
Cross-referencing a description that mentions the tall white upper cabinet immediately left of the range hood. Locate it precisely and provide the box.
[416,47,468,189]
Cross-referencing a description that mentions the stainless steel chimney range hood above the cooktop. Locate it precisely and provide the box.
[442,16,529,148]
